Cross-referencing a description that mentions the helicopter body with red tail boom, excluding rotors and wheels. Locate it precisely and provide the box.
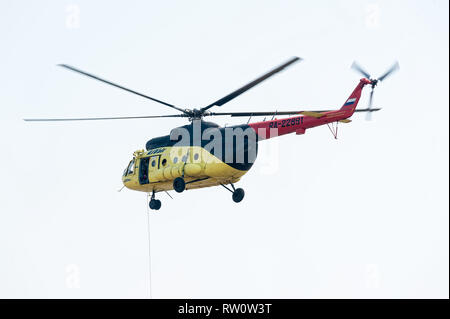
[122,79,370,193]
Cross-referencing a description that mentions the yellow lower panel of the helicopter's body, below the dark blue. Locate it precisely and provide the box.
[122,146,247,192]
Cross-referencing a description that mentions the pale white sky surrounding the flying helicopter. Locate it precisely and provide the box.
[0,1,449,298]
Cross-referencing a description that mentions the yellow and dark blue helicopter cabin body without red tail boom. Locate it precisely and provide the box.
[122,121,258,193]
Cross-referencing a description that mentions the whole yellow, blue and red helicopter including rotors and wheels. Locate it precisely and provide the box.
[24,57,399,210]
